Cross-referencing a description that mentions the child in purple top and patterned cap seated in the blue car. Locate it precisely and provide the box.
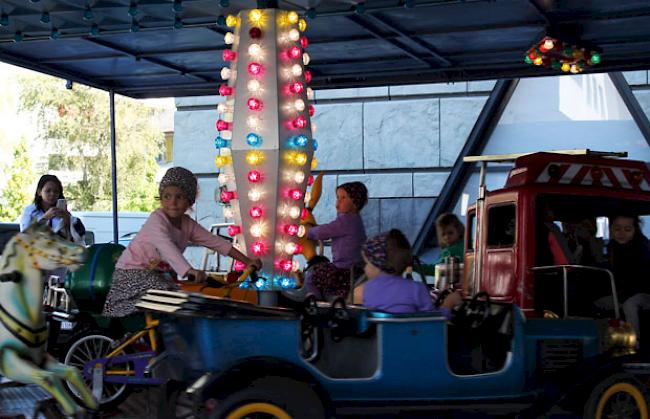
[354,229,462,316]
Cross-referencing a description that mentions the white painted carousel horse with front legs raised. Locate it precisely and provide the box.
[0,224,97,416]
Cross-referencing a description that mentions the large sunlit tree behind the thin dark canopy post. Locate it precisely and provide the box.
[20,75,164,211]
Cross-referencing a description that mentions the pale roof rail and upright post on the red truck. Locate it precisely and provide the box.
[463,148,627,293]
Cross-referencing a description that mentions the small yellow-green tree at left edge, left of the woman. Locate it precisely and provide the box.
[0,138,34,222]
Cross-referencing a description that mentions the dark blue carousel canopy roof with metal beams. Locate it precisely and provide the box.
[0,0,650,98]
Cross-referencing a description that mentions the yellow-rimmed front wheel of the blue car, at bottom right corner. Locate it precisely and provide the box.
[584,374,649,419]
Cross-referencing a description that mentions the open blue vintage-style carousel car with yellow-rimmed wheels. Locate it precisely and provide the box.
[145,291,648,418]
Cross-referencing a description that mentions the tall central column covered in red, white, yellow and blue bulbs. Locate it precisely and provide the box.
[217,9,314,290]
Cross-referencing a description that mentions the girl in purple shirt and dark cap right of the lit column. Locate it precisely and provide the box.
[305,182,368,299]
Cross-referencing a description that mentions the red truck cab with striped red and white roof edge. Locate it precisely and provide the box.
[463,150,650,318]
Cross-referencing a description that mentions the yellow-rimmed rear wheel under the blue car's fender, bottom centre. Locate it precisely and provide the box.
[210,377,325,419]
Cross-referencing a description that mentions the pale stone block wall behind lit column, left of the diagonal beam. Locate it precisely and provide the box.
[174,81,494,244]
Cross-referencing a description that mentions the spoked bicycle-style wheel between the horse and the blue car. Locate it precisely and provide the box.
[63,334,131,408]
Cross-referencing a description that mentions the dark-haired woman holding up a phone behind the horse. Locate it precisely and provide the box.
[20,175,86,244]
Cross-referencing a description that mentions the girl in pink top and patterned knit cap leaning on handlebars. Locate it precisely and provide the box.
[103,167,262,317]
